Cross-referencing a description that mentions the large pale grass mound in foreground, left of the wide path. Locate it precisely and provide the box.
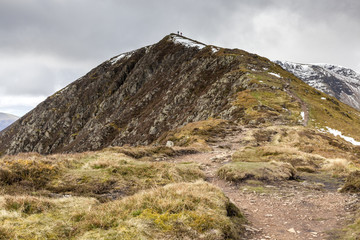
[78,182,244,239]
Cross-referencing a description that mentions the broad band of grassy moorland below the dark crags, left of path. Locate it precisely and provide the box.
[0,148,204,201]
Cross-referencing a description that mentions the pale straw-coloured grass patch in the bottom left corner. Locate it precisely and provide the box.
[0,195,99,239]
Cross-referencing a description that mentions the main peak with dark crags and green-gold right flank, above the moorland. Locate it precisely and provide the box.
[0,34,360,154]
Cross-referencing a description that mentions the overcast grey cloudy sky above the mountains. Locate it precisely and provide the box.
[0,0,360,116]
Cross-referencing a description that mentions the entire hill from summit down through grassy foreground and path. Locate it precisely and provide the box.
[0,34,360,240]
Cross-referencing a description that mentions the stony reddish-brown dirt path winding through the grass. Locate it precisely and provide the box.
[172,129,356,240]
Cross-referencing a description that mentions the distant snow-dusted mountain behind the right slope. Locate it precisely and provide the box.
[274,61,360,110]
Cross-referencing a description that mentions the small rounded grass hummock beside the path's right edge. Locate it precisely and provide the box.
[217,162,296,182]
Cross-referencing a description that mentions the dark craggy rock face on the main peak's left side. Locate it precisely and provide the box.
[0,35,282,154]
